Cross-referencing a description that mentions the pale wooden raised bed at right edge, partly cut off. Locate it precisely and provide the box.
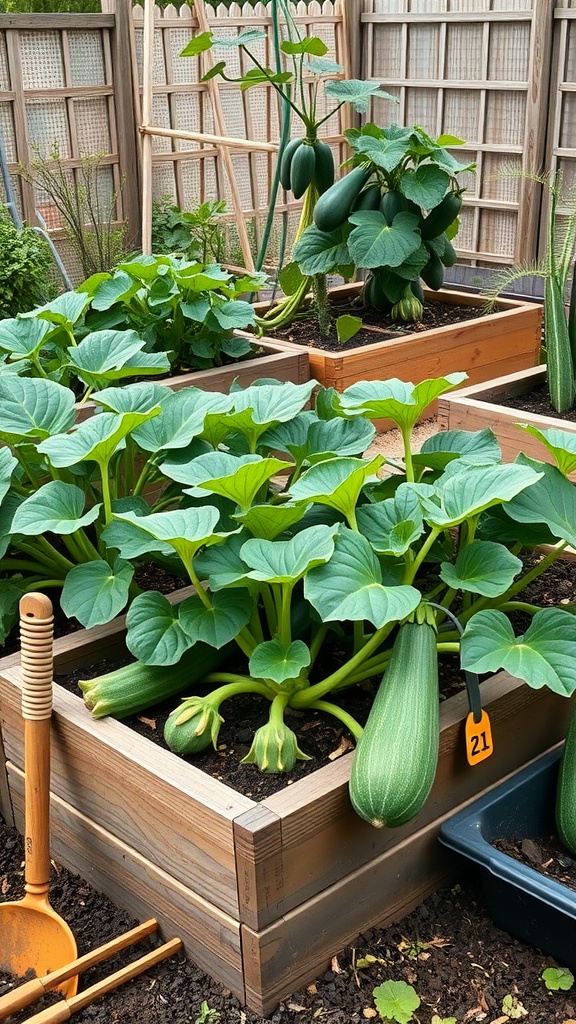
[438,366,576,463]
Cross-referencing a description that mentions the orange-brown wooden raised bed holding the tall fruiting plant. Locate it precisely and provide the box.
[258,285,542,416]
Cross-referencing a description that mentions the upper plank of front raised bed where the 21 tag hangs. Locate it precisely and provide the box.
[229,673,572,929]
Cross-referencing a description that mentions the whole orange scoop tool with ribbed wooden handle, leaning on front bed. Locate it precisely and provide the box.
[0,594,78,995]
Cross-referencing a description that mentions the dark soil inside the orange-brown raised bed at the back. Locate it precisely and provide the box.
[258,301,483,352]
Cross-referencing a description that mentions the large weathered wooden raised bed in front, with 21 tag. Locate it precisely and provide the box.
[0,606,571,1016]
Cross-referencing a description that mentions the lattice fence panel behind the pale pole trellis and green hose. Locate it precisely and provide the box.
[133,0,348,264]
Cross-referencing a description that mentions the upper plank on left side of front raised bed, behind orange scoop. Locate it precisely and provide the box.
[0,670,254,919]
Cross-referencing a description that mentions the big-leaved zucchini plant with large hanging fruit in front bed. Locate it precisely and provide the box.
[72,374,576,824]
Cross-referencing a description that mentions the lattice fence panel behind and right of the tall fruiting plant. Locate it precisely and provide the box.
[362,0,541,263]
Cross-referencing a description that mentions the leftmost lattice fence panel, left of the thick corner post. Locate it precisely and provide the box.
[0,14,121,243]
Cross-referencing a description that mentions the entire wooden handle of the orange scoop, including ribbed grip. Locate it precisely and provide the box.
[19,594,53,896]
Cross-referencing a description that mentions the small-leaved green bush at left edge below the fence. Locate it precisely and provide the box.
[0,205,56,319]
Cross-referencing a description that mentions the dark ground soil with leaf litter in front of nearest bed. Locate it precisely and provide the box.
[0,806,576,1024]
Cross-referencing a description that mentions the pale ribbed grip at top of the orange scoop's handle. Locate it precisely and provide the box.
[19,594,54,722]
